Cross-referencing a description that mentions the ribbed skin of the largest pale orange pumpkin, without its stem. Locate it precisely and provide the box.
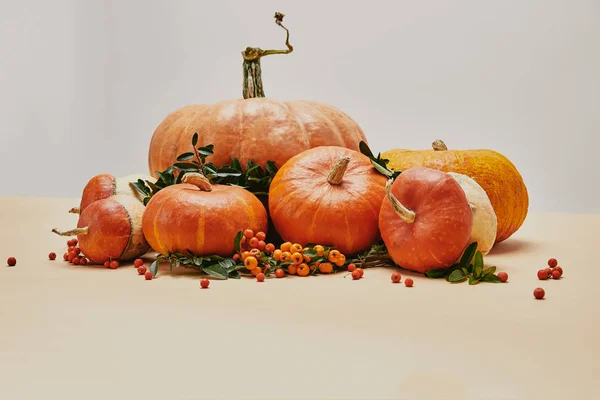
[148,98,366,177]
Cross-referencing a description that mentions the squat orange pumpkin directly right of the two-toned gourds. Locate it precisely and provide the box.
[142,173,267,257]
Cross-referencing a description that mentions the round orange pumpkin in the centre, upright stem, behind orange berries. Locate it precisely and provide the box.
[269,146,386,254]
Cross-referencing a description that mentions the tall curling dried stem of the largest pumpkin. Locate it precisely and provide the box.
[242,12,294,99]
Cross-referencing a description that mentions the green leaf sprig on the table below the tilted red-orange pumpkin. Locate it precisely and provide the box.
[425,242,502,285]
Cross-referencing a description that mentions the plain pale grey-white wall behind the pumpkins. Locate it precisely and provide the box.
[0,0,600,213]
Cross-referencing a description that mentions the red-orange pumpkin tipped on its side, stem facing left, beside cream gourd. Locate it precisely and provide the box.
[379,167,473,273]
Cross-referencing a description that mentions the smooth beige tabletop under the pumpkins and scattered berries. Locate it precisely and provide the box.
[0,197,600,400]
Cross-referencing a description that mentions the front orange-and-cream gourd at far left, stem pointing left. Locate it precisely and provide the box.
[52,194,150,264]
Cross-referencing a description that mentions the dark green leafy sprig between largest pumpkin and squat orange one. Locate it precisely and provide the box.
[131,133,278,205]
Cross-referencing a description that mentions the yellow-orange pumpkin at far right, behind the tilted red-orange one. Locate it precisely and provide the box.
[381,140,529,243]
